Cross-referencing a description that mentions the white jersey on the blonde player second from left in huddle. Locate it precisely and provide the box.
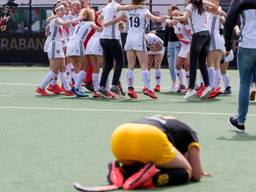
[70,21,93,41]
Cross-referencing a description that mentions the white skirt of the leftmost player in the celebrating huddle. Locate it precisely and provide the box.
[47,41,65,59]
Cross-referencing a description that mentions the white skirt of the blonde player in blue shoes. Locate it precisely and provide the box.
[67,39,85,57]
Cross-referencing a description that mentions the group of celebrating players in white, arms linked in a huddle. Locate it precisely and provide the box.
[36,0,254,102]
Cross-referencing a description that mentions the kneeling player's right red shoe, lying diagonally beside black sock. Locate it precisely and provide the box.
[123,163,159,190]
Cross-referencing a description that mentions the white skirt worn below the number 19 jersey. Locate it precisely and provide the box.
[124,33,147,51]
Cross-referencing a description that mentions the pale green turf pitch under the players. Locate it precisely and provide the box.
[0,67,256,192]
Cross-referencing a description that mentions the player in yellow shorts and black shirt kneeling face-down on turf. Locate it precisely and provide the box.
[108,116,210,190]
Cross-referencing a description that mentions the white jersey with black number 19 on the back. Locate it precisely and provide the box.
[127,9,150,35]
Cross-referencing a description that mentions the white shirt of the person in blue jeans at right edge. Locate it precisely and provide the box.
[239,9,256,49]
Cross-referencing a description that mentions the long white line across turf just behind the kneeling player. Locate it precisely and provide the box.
[0,106,256,117]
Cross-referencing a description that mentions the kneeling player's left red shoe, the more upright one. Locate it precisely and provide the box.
[107,161,124,187]
